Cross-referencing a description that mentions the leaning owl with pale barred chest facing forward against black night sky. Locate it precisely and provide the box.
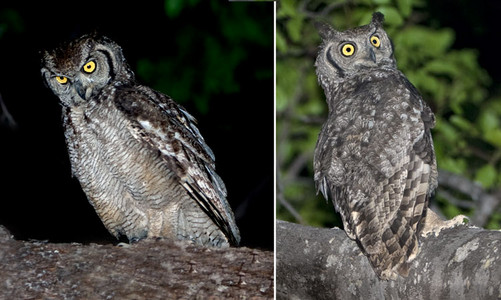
[42,35,240,247]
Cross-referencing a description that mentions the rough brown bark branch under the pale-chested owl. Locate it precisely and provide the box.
[0,226,274,299]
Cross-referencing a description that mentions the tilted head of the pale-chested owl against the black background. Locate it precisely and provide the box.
[41,35,134,107]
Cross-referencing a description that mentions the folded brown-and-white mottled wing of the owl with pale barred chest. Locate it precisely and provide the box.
[115,87,240,245]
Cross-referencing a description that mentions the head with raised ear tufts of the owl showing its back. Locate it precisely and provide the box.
[315,12,396,88]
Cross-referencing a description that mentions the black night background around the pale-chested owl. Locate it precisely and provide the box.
[0,0,274,249]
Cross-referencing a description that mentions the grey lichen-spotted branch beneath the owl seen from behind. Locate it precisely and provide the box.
[276,221,501,299]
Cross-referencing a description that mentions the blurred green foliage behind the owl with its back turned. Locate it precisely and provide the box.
[276,0,501,228]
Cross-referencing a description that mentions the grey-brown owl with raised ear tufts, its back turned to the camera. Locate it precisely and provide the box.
[314,13,437,280]
